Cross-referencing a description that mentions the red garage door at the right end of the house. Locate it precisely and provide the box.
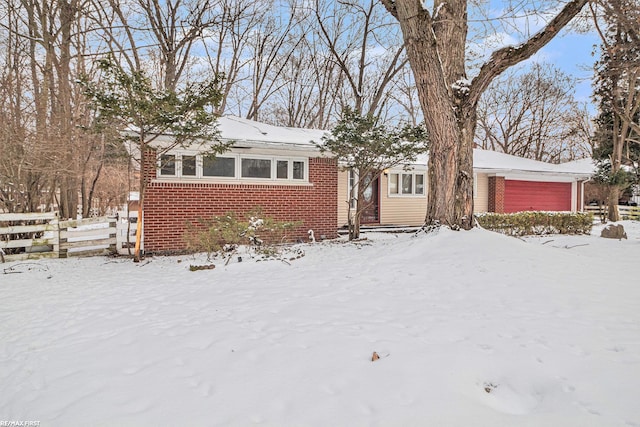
[504,180,571,213]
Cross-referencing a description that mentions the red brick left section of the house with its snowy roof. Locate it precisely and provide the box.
[143,116,338,253]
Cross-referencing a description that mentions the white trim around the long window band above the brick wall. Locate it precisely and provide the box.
[156,151,309,184]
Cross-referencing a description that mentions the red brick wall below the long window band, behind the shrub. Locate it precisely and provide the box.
[144,158,338,253]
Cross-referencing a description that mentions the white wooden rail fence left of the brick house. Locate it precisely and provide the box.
[0,212,116,262]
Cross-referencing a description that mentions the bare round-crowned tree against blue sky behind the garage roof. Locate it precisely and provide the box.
[476,63,590,163]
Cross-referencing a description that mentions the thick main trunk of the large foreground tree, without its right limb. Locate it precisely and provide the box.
[384,1,475,228]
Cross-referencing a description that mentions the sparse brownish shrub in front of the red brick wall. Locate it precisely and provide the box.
[184,208,302,259]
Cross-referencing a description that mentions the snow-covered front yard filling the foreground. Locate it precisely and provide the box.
[0,222,640,427]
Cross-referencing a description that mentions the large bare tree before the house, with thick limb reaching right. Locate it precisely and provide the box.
[381,0,588,229]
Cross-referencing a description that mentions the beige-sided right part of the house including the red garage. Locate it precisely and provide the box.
[337,149,591,227]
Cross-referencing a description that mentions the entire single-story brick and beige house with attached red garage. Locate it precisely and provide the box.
[142,116,591,253]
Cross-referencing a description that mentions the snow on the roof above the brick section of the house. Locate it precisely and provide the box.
[218,116,328,147]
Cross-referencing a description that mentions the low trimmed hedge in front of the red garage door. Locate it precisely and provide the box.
[476,211,593,236]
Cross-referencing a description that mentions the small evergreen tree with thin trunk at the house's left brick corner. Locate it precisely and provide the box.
[82,59,228,262]
